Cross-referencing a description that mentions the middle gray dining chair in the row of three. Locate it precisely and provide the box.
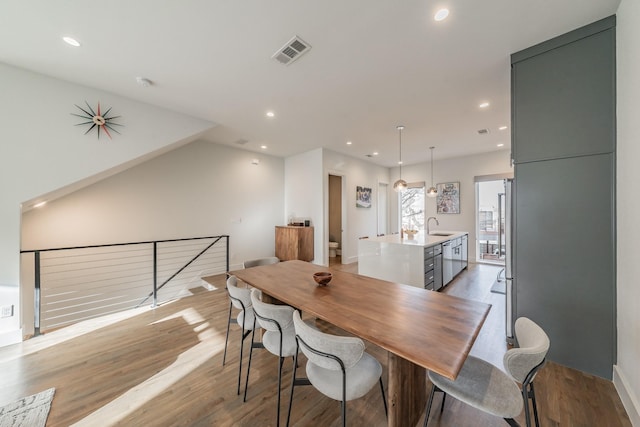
[244,289,298,426]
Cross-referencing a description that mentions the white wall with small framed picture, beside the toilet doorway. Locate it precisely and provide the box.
[322,150,389,264]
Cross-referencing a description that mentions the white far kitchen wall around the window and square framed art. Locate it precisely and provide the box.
[389,150,513,261]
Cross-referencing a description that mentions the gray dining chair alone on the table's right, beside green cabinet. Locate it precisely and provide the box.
[424,317,550,427]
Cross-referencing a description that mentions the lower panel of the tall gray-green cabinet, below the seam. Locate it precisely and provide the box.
[514,154,615,377]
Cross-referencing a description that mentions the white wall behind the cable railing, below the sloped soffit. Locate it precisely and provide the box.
[22,141,284,269]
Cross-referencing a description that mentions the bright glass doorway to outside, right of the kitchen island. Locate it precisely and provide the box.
[476,179,507,265]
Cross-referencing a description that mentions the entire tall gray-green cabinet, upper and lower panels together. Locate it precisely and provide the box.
[511,17,616,378]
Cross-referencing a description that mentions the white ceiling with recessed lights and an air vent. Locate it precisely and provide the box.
[0,0,620,167]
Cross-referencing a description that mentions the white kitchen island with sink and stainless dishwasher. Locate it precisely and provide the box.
[358,230,468,291]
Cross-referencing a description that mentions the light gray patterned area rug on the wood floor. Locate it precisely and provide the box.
[0,388,56,427]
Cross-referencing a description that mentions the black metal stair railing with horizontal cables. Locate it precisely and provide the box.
[21,235,229,335]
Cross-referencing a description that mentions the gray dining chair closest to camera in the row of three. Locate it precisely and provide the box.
[287,311,387,426]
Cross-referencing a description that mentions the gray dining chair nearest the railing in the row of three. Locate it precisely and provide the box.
[222,276,256,394]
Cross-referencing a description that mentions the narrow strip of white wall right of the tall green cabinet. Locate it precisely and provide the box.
[614,0,640,426]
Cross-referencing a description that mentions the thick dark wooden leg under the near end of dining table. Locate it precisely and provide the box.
[388,353,427,427]
